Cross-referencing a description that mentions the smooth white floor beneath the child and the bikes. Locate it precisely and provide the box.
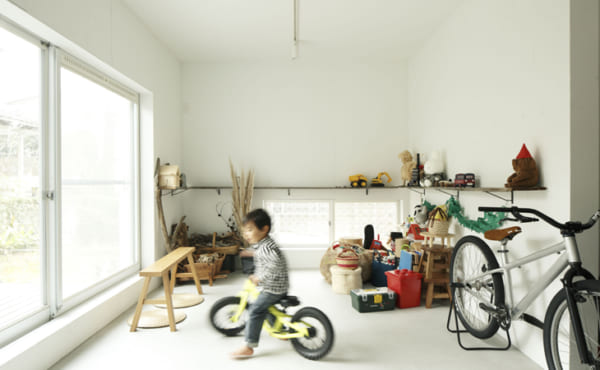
[51,270,542,370]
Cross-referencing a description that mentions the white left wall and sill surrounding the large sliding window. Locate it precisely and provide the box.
[0,0,182,369]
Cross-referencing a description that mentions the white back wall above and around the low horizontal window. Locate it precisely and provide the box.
[180,58,408,268]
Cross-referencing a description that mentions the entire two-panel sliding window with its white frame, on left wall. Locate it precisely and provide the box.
[0,21,139,345]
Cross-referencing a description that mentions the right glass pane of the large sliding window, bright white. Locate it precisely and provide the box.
[60,59,136,298]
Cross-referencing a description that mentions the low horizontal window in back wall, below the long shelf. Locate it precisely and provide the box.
[264,200,400,247]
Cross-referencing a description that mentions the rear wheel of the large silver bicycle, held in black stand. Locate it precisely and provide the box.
[450,236,504,339]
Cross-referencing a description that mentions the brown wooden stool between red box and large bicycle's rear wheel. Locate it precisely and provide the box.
[418,245,452,308]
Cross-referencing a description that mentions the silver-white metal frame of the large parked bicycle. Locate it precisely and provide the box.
[464,236,581,320]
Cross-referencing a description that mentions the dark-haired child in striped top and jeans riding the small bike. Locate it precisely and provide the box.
[231,209,289,358]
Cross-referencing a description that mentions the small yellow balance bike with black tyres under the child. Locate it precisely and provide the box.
[210,280,334,360]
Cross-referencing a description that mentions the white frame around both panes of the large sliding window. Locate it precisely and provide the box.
[0,16,142,346]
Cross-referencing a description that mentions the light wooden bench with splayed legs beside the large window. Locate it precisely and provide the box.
[129,247,202,331]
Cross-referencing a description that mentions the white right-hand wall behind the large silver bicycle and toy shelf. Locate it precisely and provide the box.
[408,0,598,366]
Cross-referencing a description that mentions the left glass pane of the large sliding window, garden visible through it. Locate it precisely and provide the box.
[0,28,44,330]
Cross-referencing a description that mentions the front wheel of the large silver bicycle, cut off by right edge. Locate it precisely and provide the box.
[544,280,600,370]
